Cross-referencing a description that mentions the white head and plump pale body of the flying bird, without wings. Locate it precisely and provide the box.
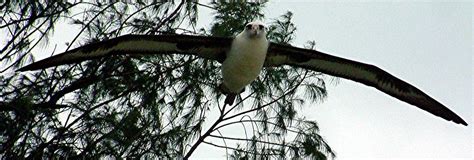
[221,22,269,105]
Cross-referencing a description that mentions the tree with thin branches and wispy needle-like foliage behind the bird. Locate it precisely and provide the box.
[0,1,335,159]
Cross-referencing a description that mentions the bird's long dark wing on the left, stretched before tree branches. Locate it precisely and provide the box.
[19,35,232,71]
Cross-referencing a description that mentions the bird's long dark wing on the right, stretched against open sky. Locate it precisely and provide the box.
[266,44,467,126]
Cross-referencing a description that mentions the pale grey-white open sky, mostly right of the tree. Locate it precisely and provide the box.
[5,1,474,160]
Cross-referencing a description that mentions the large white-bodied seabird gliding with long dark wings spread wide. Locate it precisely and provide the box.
[19,22,467,126]
